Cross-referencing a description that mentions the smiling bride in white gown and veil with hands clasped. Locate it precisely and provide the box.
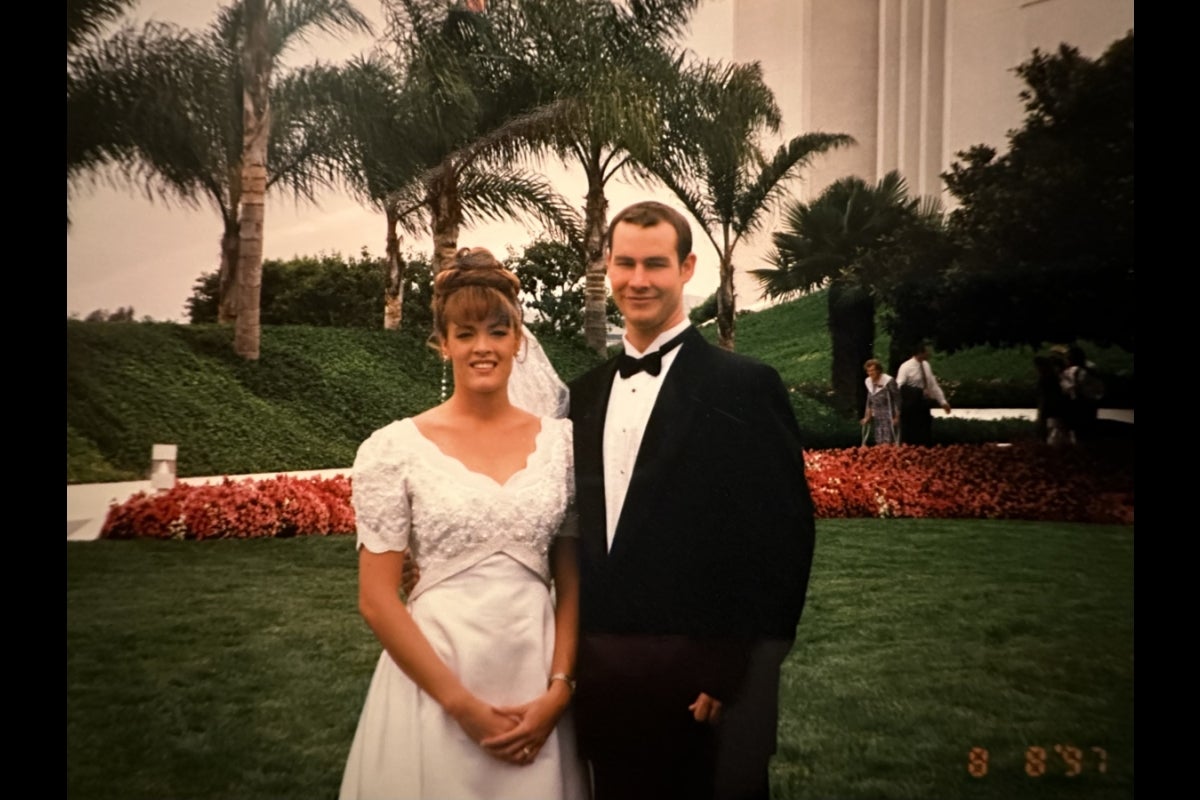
[341,248,588,800]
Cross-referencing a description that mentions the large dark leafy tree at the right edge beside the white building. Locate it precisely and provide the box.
[920,31,1135,350]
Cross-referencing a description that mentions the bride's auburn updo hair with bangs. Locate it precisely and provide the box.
[431,247,522,344]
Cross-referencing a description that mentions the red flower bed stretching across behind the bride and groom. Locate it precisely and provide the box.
[101,443,1133,539]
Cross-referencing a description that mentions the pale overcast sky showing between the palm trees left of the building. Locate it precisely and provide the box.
[67,0,732,321]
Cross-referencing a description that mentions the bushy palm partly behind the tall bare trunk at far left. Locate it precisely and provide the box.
[68,0,370,335]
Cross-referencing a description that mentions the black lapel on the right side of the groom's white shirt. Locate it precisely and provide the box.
[610,329,710,558]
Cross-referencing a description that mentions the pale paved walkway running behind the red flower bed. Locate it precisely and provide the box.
[67,408,1133,542]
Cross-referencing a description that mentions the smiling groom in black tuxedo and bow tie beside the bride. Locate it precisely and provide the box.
[570,203,814,800]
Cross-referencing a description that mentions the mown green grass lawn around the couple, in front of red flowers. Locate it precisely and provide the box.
[67,519,1133,800]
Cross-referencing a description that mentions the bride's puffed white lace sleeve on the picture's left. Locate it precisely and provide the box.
[350,422,413,553]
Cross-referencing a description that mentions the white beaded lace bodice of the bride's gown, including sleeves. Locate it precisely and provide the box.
[350,417,577,599]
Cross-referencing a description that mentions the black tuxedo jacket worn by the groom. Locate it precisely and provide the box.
[570,329,814,676]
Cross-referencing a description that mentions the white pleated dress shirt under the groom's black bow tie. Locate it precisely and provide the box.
[604,319,691,549]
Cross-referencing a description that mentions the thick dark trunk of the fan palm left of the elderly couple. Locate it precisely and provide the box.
[829,281,875,419]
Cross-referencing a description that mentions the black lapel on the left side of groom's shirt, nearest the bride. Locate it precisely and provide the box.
[575,359,617,564]
